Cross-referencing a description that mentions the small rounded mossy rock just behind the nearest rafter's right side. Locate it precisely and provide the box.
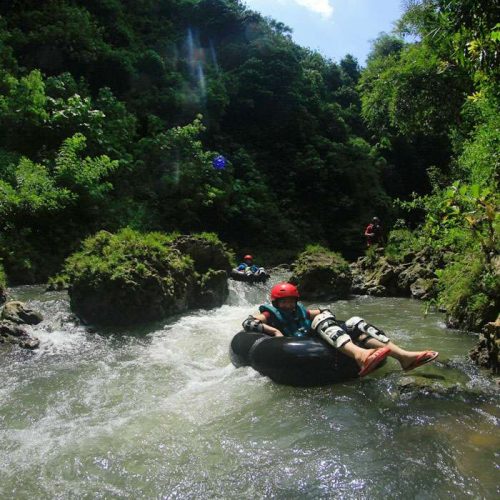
[290,245,352,300]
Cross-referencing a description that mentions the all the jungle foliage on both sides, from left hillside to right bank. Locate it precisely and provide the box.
[0,0,500,330]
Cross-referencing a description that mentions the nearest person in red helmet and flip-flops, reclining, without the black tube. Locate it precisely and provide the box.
[243,283,439,377]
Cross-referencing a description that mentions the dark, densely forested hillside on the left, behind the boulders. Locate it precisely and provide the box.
[0,0,390,283]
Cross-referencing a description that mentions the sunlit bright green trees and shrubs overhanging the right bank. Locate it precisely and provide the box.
[360,0,500,330]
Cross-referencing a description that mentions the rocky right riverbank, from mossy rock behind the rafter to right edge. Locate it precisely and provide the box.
[291,246,500,375]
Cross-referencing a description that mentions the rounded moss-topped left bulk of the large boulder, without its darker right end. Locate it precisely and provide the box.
[60,228,194,324]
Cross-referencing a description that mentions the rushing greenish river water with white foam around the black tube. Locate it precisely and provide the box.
[0,282,500,499]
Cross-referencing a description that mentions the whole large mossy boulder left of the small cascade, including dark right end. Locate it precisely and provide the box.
[63,229,230,325]
